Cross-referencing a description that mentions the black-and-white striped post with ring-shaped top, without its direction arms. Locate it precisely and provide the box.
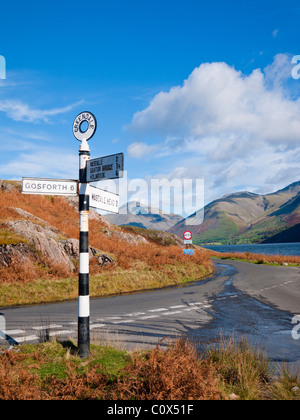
[73,112,96,358]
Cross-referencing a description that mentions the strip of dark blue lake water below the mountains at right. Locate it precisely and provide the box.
[200,242,300,255]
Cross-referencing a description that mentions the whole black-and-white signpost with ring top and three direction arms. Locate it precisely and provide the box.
[22,111,124,358]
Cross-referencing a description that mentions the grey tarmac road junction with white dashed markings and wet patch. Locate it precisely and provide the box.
[0,259,300,365]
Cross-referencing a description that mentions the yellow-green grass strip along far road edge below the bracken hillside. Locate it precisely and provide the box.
[0,261,213,308]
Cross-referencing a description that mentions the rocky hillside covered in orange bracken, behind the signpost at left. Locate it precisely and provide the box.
[0,181,213,307]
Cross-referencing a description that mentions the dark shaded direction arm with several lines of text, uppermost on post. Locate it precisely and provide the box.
[86,153,124,182]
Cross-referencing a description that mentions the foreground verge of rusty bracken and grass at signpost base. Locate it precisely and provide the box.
[0,339,300,400]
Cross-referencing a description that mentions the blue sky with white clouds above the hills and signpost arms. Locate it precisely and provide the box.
[0,0,300,215]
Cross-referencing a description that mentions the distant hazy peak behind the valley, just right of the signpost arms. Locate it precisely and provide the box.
[104,201,183,231]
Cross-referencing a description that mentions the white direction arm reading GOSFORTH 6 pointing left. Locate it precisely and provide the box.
[22,178,78,196]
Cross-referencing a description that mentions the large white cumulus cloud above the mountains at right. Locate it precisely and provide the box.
[129,54,300,203]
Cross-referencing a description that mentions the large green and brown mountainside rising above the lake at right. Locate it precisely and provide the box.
[169,182,300,244]
